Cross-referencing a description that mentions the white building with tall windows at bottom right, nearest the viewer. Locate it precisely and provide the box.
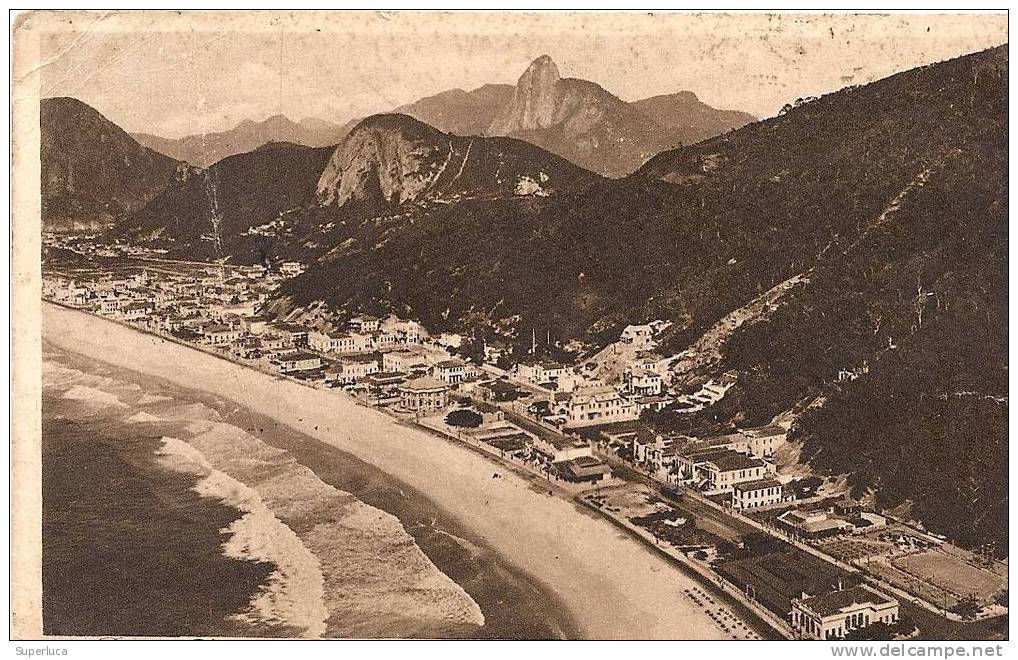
[792,585,898,640]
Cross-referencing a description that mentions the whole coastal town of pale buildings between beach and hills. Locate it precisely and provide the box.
[43,235,1008,640]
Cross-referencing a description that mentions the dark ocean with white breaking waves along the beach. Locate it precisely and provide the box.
[43,343,573,639]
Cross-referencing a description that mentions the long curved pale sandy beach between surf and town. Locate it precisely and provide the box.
[42,304,727,639]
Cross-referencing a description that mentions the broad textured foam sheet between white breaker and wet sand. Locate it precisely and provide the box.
[188,423,485,637]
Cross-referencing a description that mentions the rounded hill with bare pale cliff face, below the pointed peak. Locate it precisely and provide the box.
[318,114,599,212]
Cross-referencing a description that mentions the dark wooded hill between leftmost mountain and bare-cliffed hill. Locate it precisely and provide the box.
[121,143,333,261]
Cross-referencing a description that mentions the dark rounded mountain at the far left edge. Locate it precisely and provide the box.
[40,98,186,231]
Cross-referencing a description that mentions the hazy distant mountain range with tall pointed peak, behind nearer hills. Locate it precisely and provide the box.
[134,55,755,177]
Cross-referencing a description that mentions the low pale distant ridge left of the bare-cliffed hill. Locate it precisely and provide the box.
[133,115,352,167]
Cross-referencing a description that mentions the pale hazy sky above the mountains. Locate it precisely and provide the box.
[29,12,1007,138]
